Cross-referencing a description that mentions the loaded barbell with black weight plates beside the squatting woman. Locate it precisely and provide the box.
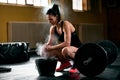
[74,40,118,77]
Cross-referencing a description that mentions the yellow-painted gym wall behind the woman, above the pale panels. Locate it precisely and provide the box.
[0,0,107,42]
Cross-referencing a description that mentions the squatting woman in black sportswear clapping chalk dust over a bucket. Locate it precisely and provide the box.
[44,4,81,71]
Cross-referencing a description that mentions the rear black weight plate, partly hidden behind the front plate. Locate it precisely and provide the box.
[97,40,118,64]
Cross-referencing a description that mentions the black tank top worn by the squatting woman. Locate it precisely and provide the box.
[55,21,82,48]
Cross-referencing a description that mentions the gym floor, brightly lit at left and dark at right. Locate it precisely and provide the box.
[0,49,120,80]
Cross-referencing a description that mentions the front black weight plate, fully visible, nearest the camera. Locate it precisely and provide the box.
[74,43,107,76]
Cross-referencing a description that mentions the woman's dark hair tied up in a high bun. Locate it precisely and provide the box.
[46,4,61,22]
